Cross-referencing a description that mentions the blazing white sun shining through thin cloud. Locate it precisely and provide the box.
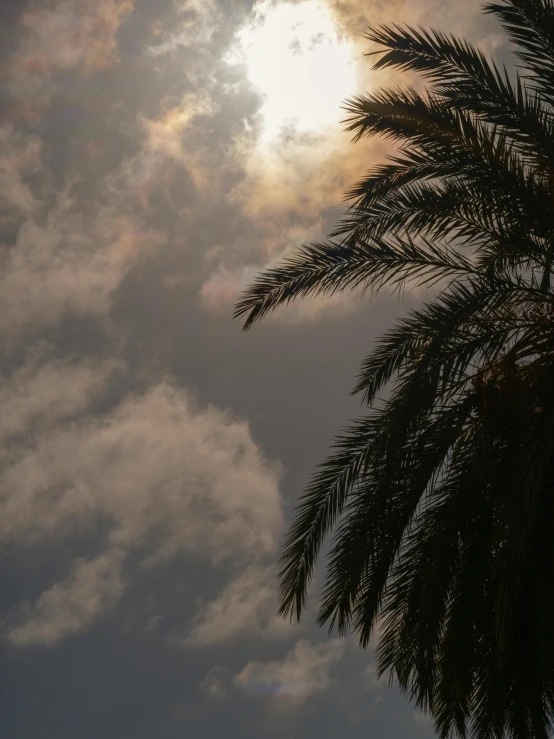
[227,0,355,139]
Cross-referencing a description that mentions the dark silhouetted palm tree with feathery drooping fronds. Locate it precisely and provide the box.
[236,0,554,739]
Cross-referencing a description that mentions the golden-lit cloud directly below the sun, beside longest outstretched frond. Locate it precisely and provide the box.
[200,125,383,320]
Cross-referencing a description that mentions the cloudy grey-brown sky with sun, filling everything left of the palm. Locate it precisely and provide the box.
[0,0,508,739]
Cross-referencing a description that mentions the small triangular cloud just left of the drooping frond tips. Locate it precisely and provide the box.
[179,564,293,647]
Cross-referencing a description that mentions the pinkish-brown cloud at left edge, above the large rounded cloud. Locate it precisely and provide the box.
[0,110,171,345]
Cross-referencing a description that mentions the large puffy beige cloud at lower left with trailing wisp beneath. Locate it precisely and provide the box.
[0,373,282,646]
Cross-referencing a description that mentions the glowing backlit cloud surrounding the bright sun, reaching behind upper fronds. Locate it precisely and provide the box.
[195,0,508,321]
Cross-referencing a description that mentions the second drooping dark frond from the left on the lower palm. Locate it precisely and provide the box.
[318,394,473,646]
